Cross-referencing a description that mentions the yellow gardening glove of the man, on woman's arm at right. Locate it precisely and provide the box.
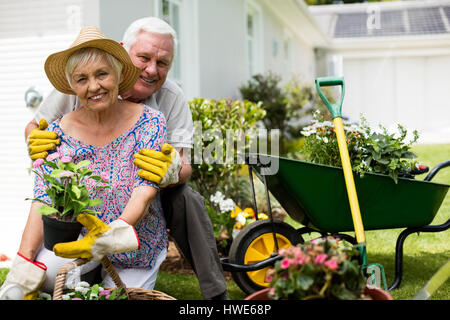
[134,143,181,188]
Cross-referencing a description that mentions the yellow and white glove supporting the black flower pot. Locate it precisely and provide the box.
[53,213,139,261]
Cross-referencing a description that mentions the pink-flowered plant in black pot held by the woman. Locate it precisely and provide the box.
[26,152,109,250]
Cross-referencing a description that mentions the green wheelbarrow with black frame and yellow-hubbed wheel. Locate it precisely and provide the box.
[221,127,450,294]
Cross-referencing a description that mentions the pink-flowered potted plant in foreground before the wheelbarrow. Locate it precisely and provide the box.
[247,237,392,300]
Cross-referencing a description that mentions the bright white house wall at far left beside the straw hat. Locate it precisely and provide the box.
[0,0,98,257]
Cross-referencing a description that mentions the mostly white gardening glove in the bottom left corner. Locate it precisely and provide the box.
[0,252,47,300]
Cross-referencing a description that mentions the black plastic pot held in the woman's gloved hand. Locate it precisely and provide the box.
[42,216,83,251]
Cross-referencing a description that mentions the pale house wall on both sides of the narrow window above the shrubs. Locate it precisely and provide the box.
[198,0,315,99]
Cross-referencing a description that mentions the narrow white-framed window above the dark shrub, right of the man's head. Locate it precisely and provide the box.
[246,1,263,77]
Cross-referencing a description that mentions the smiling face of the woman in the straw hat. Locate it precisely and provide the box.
[71,57,119,111]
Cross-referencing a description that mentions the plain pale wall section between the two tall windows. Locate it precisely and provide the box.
[198,0,247,99]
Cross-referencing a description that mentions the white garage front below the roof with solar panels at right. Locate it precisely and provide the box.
[330,48,450,143]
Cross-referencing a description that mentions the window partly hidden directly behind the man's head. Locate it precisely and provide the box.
[158,0,182,86]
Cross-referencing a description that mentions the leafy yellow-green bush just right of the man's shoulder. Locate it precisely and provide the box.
[189,98,266,199]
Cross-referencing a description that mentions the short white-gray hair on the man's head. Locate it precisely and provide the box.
[122,17,178,57]
